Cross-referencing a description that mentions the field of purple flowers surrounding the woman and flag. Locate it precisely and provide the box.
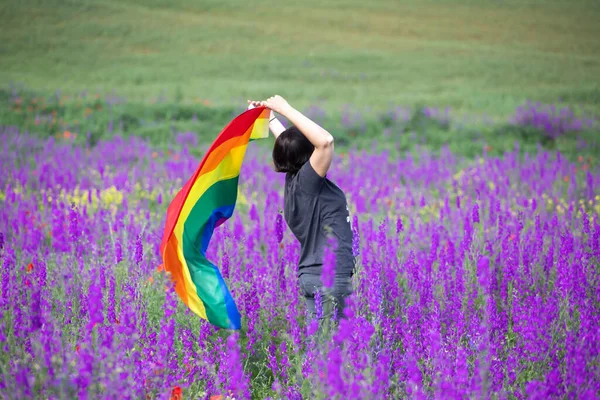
[0,128,600,399]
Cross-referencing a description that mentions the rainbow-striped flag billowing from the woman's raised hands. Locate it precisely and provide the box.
[160,107,270,329]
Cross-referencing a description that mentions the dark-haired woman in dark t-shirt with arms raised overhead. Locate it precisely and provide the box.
[248,96,355,336]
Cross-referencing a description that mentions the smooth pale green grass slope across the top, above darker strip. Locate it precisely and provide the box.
[0,0,600,116]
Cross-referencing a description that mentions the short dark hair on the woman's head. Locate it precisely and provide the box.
[273,126,315,174]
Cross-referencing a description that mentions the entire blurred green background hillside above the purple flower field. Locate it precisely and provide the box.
[0,0,600,159]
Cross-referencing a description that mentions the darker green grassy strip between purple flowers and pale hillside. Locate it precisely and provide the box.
[0,83,600,168]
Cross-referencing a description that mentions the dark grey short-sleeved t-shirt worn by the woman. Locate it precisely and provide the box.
[284,161,355,276]
